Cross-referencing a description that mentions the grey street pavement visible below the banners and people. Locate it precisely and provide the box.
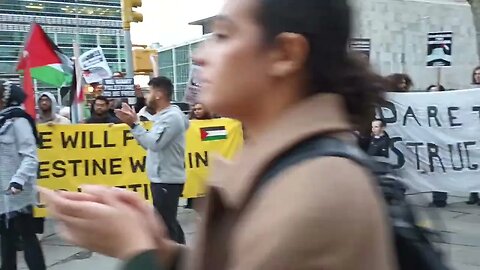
[14,195,480,270]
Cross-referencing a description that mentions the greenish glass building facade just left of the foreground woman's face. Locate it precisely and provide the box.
[158,36,206,101]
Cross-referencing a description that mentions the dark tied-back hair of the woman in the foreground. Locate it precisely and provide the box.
[257,0,386,130]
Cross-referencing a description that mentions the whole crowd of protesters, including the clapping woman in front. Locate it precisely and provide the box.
[0,0,480,270]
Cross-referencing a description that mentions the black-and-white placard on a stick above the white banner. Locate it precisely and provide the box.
[427,32,453,67]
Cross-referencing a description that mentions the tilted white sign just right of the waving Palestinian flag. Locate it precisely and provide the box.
[79,47,112,83]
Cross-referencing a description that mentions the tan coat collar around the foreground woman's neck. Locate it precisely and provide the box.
[210,94,352,208]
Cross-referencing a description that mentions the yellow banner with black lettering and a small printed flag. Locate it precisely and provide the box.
[35,118,243,217]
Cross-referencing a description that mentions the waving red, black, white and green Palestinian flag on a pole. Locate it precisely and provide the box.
[17,23,73,87]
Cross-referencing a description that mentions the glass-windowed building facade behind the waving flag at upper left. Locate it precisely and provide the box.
[0,0,125,84]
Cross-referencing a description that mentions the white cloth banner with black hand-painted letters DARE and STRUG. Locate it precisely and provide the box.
[381,89,480,196]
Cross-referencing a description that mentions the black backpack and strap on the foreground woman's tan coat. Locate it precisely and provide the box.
[252,137,448,270]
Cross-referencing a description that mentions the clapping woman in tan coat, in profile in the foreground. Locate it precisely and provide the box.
[43,0,396,270]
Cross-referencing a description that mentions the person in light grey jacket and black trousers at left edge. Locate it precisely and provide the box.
[0,81,46,270]
